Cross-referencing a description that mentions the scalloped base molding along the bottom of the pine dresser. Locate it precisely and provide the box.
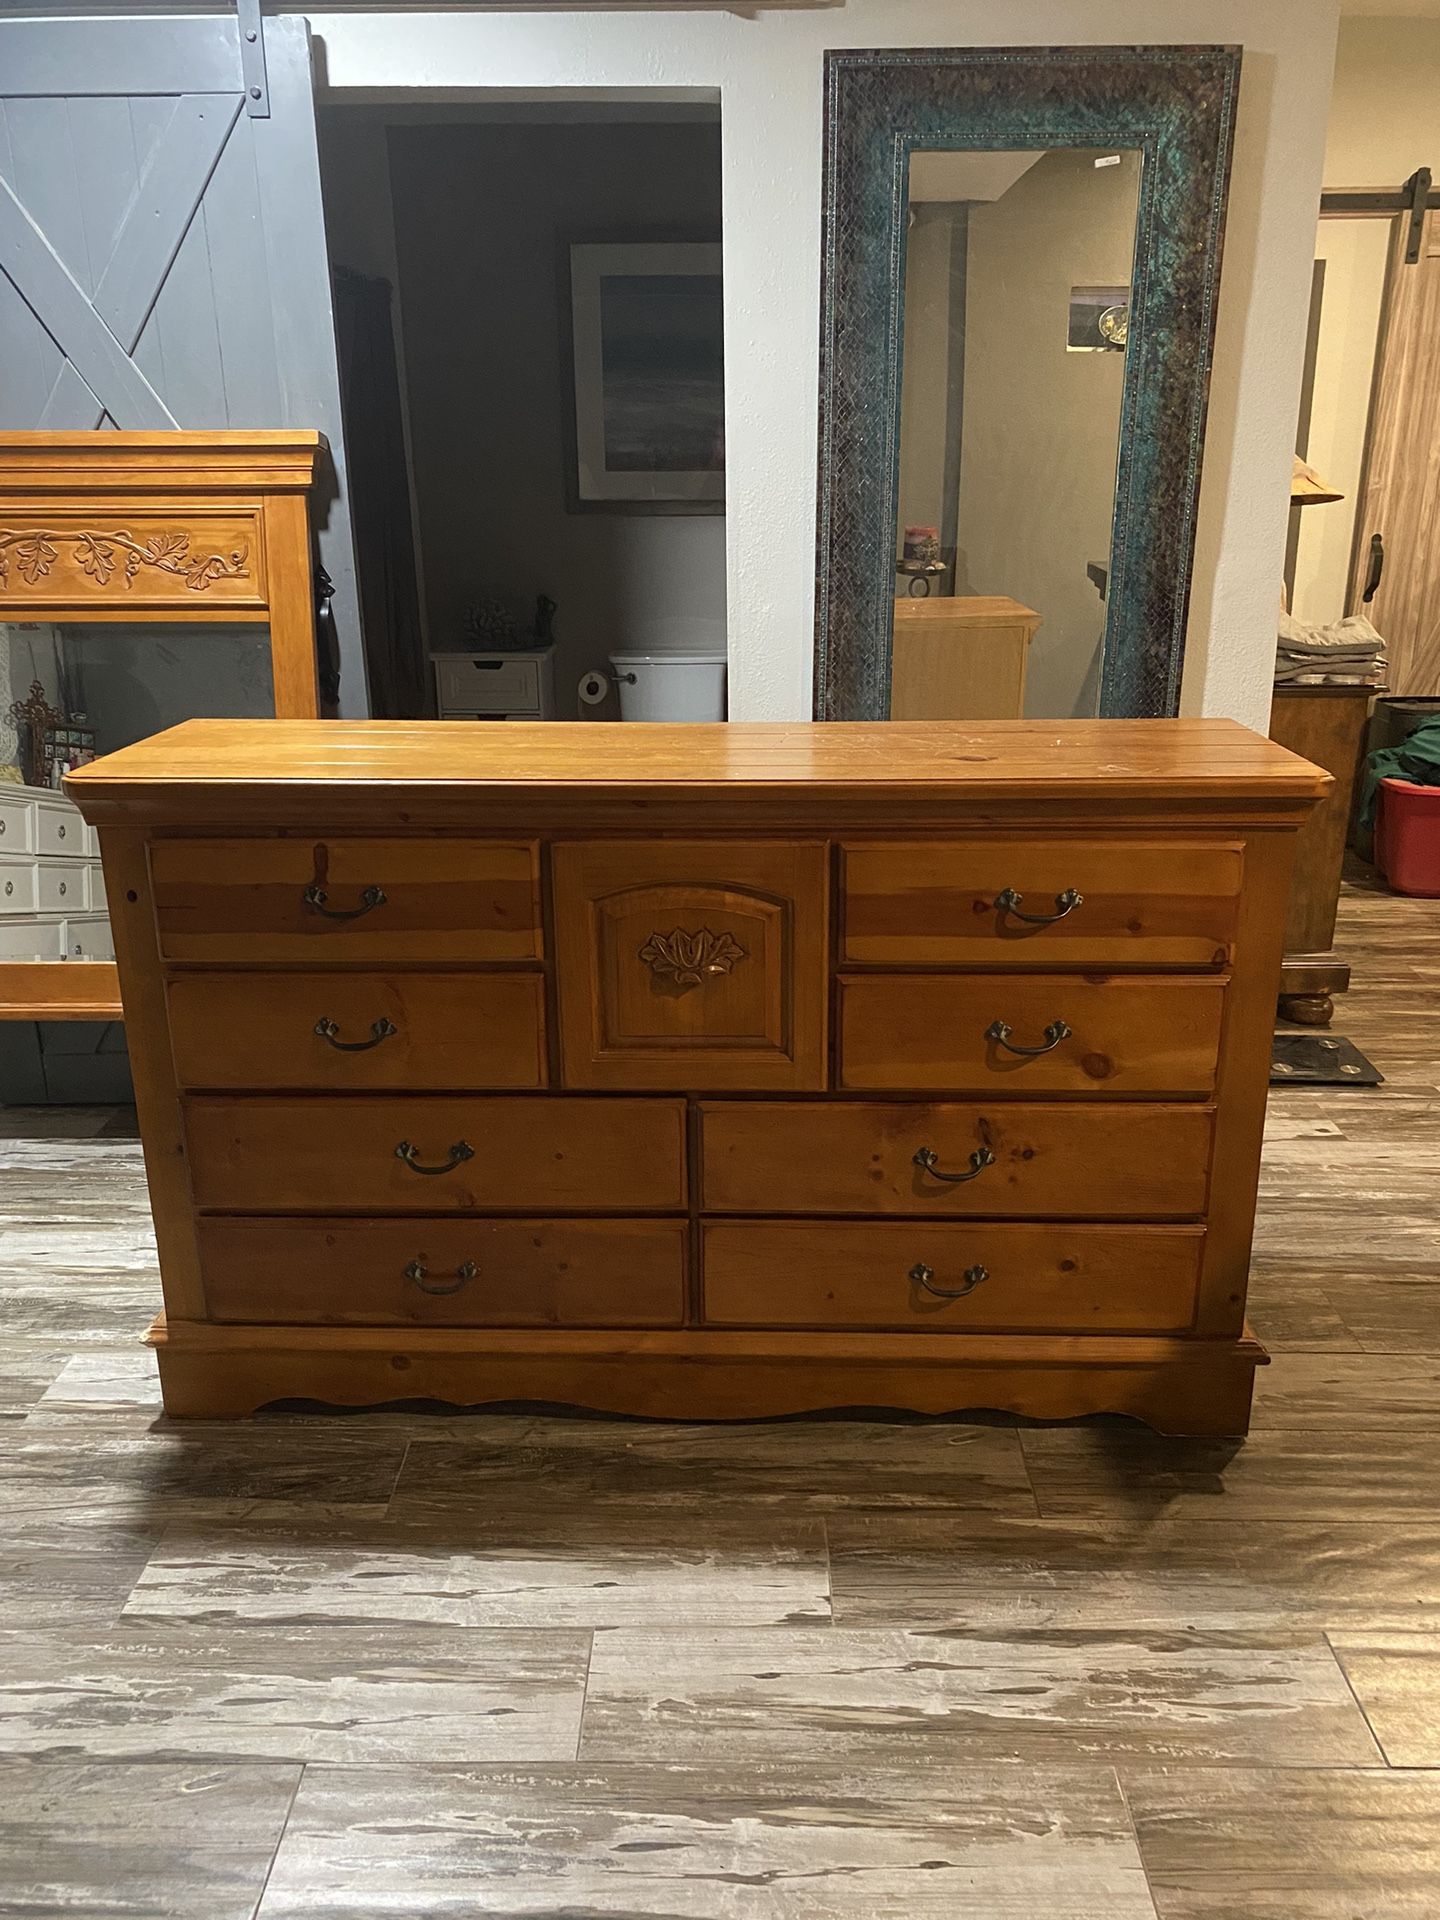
[150,1313,1269,1436]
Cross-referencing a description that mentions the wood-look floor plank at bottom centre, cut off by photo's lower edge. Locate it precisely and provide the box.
[259,1755,1154,1920]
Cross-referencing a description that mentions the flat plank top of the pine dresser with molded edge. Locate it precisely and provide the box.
[65,720,1329,824]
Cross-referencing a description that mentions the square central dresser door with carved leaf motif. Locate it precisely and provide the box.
[555,841,826,1092]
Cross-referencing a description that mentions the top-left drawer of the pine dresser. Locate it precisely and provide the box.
[150,839,540,966]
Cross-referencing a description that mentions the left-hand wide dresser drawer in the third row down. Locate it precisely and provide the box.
[184,1094,685,1213]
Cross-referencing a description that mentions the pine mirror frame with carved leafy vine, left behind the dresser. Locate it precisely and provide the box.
[0,430,328,1020]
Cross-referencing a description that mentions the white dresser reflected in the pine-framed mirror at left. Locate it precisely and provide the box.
[0,785,115,960]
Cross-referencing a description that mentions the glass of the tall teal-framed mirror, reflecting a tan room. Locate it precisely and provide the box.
[891,148,1140,720]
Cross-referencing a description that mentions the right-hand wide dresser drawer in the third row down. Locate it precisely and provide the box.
[701,1100,1213,1219]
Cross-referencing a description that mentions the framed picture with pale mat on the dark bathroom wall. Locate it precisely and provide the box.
[566,240,726,513]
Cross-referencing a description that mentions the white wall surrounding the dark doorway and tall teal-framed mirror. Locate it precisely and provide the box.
[313,0,1336,728]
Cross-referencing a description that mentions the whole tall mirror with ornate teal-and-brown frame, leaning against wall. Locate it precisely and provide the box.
[816,48,1238,720]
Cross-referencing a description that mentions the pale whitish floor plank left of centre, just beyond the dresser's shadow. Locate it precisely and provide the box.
[125,1507,829,1628]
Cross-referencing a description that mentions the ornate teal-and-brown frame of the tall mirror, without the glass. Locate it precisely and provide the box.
[814,46,1240,720]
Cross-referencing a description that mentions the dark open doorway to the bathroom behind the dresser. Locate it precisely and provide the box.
[321,94,726,720]
